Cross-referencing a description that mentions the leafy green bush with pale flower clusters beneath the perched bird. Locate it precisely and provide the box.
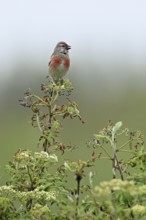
[0,79,146,220]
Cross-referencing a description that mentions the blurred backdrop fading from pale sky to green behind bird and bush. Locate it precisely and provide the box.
[0,0,146,182]
